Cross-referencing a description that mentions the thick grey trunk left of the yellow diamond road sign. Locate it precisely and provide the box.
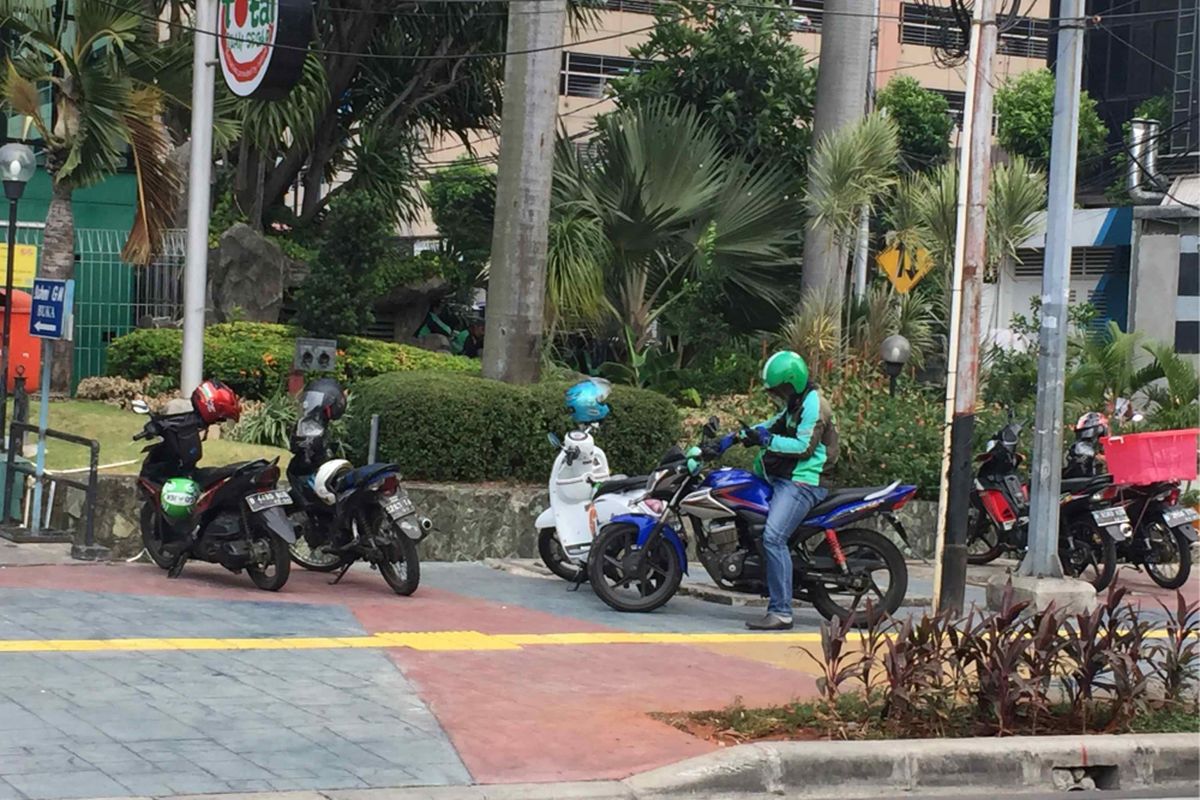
[800,0,876,299]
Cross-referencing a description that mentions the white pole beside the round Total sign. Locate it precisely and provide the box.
[179,0,217,397]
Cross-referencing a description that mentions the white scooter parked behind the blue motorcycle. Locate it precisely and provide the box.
[534,423,646,583]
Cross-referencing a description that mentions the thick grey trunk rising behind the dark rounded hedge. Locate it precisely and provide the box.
[484,0,566,384]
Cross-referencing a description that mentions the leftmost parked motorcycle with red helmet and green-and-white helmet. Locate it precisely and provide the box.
[133,380,295,591]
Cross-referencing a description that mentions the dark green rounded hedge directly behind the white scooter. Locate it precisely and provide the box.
[349,372,679,482]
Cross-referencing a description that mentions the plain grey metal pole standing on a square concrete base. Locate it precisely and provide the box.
[1018,0,1084,578]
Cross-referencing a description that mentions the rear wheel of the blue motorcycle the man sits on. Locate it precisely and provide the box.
[806,528,908,627]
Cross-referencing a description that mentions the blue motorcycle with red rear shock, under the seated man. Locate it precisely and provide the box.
[588,420,917,625]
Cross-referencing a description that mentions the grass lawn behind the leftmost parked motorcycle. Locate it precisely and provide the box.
[10,398,288,475]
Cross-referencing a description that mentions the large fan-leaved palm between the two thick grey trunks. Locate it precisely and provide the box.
[550,101,798,355]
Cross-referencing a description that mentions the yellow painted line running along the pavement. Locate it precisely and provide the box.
[0,630,1168,654]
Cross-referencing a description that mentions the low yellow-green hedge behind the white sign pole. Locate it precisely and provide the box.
[108,323,479,399]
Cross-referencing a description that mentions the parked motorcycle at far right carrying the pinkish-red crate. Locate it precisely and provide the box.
[1064,409,1200,589]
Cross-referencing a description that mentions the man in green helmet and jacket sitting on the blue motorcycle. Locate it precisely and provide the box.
[743,350,838,631]
